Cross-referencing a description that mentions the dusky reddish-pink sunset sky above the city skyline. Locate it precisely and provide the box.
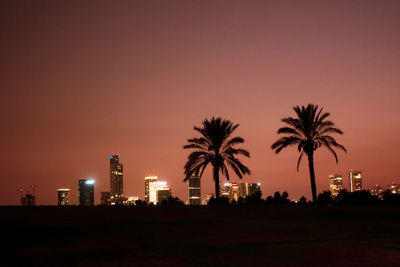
[0,0,400,205]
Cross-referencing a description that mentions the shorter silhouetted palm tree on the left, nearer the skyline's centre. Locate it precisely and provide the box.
[183,117,250,199]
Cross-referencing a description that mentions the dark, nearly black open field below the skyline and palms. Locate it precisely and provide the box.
[0,206,400,266]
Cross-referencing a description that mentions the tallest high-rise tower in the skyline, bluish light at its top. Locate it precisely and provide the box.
[109,155,124,205]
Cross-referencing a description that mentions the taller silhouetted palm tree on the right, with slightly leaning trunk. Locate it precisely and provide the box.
[271,104,347,203]
